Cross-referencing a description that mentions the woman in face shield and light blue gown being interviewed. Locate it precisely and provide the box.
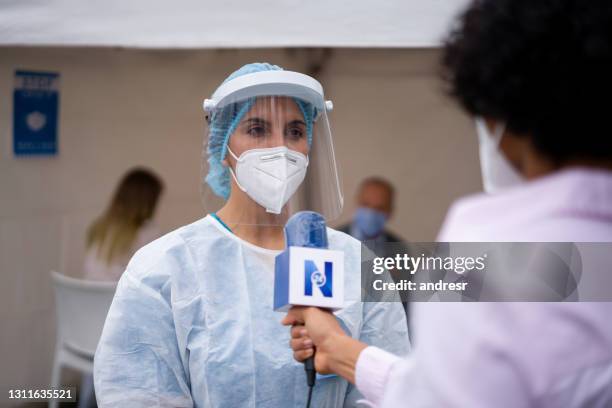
[94,63,408,408]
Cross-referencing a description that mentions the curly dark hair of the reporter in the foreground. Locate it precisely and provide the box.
[442,0,612,163]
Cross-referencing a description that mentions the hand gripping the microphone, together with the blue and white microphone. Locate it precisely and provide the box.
[274,211,366,389]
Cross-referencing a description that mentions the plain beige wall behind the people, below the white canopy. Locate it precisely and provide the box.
[0,48,480,389]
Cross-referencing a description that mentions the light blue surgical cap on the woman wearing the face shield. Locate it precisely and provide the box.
[206,62,316,200]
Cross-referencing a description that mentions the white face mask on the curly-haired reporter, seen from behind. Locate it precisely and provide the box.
[476,117,523,193]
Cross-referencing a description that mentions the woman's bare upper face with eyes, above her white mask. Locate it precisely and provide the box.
[226,96,309,159]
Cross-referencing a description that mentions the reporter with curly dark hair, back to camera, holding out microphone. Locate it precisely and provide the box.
[284,0,612,408]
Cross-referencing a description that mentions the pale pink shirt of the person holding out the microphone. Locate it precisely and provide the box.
[355,168,612,408]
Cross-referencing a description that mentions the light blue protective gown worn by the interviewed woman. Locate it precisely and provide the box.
[94,215,409,408]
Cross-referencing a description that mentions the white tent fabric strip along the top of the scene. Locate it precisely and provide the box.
[0,0,467,48]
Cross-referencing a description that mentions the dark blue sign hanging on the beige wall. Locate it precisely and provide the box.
[13,71,59,156]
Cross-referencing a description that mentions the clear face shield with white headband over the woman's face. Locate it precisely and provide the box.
[203,71,343,228]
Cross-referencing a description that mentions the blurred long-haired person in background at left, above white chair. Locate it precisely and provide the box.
[84,168,164,281]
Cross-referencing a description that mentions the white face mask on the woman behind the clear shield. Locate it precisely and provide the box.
[227,146,308,214]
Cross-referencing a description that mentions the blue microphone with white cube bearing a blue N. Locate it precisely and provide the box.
[274,211,344,406]
